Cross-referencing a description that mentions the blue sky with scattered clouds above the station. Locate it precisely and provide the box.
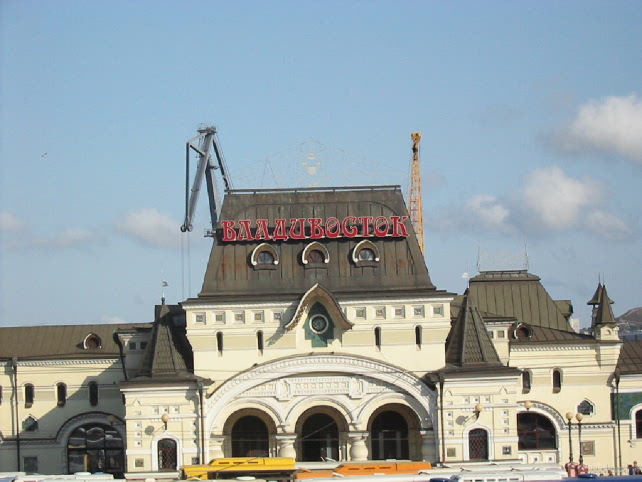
[0,0,642,326]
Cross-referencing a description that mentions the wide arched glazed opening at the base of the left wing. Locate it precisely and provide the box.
[67,423,125,478]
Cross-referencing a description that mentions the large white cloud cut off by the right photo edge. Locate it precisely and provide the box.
[558,94,642,164]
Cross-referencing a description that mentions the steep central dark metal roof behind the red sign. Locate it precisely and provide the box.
[199,186,435,300]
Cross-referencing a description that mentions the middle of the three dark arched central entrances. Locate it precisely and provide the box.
[300,413,339,462]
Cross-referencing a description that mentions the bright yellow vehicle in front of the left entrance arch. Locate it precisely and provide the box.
[181,457,296,480]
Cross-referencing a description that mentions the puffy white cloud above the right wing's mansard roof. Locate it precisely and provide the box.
[521,166,602,231]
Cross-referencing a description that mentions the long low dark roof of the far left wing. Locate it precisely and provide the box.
[0,323,152,360]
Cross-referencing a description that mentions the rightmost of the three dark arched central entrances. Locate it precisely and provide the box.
[370,410,410,460]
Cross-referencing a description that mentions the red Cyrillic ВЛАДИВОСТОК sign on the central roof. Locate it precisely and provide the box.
[221,216,408,242]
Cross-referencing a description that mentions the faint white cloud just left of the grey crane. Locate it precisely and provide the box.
[117,209,181,249]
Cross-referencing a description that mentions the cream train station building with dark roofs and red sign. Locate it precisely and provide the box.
[0,186,642,474]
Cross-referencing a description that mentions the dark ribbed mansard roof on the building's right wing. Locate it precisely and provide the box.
[462,270,573,332]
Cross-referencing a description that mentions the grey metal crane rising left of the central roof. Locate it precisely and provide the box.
[181,126,233,236]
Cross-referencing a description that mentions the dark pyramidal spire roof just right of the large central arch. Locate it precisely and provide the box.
[446,290,503,368]
